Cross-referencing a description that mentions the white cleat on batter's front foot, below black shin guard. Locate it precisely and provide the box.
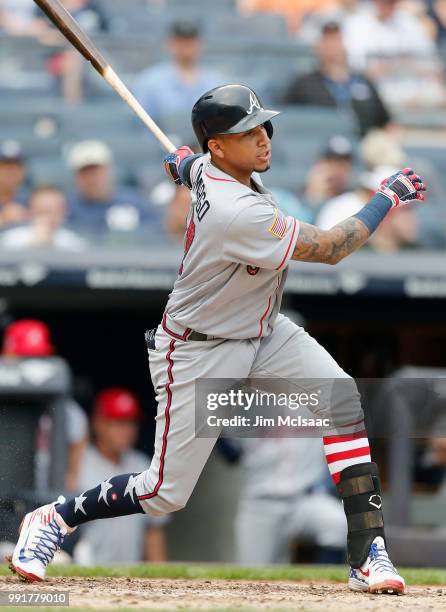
[348,536,406,595]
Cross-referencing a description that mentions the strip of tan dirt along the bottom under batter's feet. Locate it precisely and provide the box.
[0,576,446,612]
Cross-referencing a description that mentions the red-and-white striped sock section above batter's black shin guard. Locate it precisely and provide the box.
[324,431,372,484]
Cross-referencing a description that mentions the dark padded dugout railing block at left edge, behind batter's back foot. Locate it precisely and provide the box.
[0,357,71,541]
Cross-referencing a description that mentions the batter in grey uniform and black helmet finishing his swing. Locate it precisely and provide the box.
[11,85,426,593]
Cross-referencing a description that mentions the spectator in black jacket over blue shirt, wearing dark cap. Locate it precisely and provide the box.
[284,21,390,134]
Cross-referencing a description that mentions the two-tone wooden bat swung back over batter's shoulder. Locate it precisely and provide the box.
[34,0,177,153]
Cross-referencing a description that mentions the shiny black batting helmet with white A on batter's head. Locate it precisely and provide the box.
[192,85,279,153]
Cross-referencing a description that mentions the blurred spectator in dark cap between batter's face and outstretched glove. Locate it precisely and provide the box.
[298,136,353,223]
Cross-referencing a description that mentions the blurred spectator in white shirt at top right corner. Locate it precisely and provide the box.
[343,0,445,108]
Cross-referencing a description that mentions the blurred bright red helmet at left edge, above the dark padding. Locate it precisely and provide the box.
[3,319,54,357]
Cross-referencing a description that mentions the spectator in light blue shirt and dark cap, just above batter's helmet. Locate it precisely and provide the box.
[135,21,224,130]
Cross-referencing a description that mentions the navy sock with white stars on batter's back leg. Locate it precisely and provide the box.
[53,474,144,527]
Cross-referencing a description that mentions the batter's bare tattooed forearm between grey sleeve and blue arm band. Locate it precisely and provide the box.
[293,217,369,264]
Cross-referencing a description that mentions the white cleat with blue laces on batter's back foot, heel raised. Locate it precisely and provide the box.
[9,497,76,582]
